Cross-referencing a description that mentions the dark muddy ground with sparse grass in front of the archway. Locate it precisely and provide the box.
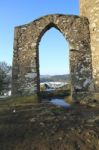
[0,103,99,150]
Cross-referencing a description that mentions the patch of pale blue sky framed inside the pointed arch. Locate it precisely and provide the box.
[39,28,69,75]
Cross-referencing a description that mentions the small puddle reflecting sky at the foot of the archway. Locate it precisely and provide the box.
[50,98,70,108]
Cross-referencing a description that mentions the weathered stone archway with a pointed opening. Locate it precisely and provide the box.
[12,14,92,99]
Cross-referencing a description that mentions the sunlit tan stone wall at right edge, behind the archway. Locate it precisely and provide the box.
[80,0,99,92]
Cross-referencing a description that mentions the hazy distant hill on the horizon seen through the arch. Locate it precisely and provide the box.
[40,74,70,82]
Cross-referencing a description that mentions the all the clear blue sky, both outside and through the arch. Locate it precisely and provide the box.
[0,0,79,74]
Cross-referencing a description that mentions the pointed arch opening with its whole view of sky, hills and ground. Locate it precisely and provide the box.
[38,24,71,100]
